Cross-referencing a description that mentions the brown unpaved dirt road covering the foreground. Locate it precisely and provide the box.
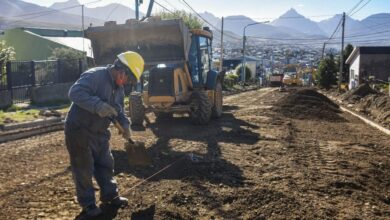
[0,88,390,219]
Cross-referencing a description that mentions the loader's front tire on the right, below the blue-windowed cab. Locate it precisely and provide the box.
[190,91,212,125]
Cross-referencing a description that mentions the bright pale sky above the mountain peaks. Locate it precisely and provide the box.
[24,0,390,21]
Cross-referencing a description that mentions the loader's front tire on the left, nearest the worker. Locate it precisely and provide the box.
[129,93,145,125]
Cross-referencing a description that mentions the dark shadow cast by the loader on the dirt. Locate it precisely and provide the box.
[112,106,260,187]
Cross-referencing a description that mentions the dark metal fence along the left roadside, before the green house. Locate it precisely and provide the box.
[0,59,88,103]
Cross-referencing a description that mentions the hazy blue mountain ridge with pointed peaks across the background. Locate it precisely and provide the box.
[0,0,390,46]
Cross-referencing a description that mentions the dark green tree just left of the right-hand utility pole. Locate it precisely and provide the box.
[317,54,337,89]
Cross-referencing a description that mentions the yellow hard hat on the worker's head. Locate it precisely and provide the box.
[117,51,145,81]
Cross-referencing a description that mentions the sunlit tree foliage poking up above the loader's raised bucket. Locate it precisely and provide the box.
[156,10,203,29]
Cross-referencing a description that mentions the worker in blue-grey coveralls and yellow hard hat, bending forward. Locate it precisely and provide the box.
[65,51,144,216]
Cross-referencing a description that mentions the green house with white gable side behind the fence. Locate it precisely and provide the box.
[0,28,93,60]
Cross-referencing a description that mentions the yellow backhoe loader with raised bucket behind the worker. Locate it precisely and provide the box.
[86,17,223,125]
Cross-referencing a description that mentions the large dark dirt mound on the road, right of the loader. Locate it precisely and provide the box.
[276,89,341,121]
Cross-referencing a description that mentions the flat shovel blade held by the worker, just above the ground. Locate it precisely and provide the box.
[125,142,152,166]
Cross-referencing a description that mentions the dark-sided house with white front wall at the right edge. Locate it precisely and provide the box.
[346,46,390,89]
